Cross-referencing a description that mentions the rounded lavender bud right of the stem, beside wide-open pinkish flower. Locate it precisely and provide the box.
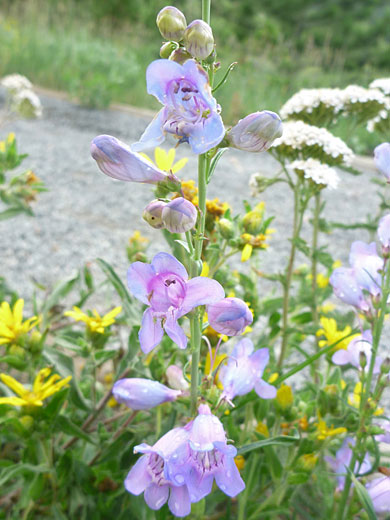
[207,298,253,336]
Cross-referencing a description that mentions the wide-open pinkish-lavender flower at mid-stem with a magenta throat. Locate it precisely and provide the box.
[127,253,225,354]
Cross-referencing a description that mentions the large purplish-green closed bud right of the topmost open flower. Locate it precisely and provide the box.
[226,110,283,152]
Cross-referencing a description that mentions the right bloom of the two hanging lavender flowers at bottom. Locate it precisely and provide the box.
[167,405,245,502]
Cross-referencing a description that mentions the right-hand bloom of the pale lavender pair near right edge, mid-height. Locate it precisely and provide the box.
[349,240,383,296]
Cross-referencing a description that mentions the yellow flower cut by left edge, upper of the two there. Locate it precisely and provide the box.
[0,298,40,345]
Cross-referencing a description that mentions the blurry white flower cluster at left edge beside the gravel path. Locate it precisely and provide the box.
[0,74,42,118]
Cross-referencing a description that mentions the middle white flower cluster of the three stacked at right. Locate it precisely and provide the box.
[271,121,354,166]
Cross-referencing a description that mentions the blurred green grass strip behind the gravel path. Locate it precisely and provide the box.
[0,4,383,151]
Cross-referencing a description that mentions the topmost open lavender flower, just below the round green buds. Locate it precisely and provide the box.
[131,60,225,154]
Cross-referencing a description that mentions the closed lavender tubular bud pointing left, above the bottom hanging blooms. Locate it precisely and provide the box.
[112,378,181,410]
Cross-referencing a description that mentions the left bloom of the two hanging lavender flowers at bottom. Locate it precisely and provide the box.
[125,428,191,517]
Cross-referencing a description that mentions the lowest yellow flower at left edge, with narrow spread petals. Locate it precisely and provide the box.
[0,368,72,406]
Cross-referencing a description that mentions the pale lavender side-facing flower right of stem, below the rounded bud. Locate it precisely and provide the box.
[219,338,276,402]
